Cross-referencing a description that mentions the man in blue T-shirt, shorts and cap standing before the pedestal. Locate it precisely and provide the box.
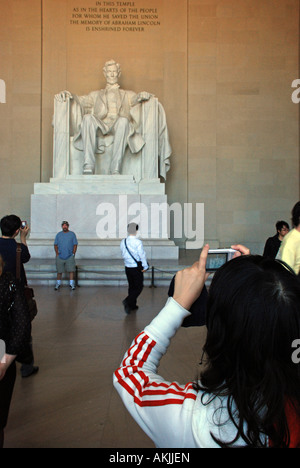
[54,221,78,291]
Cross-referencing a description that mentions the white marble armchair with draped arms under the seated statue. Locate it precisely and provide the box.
[53,97,172,182]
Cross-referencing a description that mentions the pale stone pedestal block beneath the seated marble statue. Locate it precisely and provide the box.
[28,175,179,260]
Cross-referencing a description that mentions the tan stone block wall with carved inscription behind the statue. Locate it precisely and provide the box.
[0,0,299,252]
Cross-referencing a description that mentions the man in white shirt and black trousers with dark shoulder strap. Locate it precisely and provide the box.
[120,223,149,314]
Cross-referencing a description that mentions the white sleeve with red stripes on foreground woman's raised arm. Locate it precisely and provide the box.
[114,298,197,448]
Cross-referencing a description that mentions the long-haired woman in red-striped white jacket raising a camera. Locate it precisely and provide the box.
[114,245,300,448]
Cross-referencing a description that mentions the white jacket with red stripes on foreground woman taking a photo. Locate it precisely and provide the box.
[114,298,255,448]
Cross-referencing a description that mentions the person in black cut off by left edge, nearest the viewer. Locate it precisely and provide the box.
[0,256,31,448]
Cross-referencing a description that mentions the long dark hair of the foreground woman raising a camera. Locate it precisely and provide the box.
[197,256,300,447]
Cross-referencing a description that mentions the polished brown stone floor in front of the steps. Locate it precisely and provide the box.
[4,286,205,448]
